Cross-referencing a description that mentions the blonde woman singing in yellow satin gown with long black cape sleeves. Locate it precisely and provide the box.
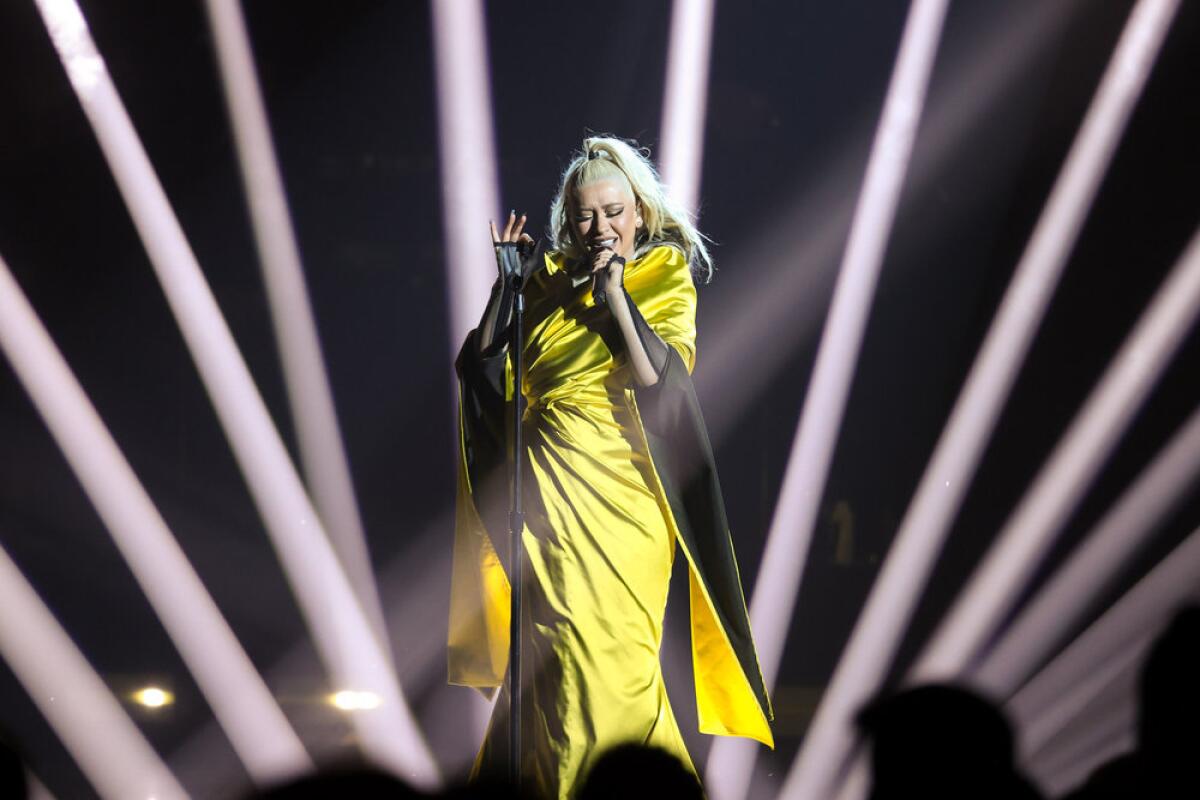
[449,137,773,798]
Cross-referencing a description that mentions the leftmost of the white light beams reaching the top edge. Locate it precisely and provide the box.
[37,0,439,788]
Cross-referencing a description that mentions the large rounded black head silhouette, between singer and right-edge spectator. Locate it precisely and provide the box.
[858,685,1037,800]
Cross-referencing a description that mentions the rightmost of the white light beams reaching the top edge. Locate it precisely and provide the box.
[768,0,1176,796]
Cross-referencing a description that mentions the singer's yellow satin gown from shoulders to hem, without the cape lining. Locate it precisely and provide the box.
[476,247,696,798]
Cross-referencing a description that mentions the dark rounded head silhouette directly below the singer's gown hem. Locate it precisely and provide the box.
[578,745,704,800]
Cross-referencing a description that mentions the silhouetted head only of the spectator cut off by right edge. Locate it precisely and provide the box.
[1138,606,1200,760]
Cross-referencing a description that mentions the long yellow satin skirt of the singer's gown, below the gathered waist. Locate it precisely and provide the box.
[476,387,691,798]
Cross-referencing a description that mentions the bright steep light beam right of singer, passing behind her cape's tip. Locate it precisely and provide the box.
[704,0,947,800]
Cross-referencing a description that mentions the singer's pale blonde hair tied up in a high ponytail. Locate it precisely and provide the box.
[550,136,713,283]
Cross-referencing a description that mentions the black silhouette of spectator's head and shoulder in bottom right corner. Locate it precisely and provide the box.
[1063,606,1200,800]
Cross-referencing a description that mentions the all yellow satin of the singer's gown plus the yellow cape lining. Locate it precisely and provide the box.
[449,246,773,798]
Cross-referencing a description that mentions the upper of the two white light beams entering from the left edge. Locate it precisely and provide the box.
[0,258,312,783]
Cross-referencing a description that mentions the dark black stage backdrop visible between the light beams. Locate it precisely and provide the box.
[0,0,1200,798]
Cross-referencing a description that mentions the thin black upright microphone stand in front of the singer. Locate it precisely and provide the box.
[505,261,524,793]
